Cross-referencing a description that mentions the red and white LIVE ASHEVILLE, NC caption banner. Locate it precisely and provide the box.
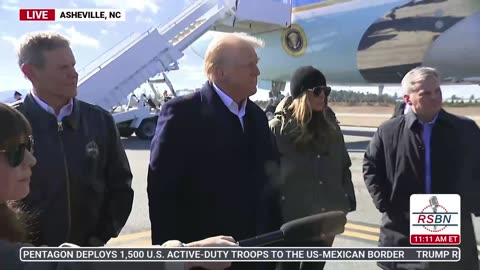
[19,8,126,22]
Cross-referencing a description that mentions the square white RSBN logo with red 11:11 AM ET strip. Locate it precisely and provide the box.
[410,194,461,246]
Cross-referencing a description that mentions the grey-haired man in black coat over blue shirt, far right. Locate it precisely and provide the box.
[363,67,480,270]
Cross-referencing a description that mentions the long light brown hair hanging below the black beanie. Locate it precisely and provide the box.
[288,92,335,146]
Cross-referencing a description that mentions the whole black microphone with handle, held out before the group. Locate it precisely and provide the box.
[238,211,347,247]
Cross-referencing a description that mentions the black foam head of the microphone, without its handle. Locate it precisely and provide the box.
[280,211,347,242]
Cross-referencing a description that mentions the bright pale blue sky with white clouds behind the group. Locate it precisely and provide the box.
[0,0,480,103]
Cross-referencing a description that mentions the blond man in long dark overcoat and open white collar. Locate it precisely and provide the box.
[148,34,281,269]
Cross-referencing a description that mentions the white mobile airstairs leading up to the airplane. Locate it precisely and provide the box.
[78,0,291,139]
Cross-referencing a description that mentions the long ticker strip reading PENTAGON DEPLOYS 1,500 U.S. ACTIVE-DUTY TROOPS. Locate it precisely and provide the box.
[19,247,461,262]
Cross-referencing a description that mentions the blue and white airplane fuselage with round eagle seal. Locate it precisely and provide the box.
[190,0,480,96]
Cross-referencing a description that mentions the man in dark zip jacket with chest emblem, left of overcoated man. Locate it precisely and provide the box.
[14,33,133,246]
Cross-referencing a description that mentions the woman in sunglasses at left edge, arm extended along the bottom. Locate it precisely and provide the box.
[0,103,238,270]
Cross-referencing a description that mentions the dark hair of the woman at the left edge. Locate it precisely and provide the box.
[0,103,32,242]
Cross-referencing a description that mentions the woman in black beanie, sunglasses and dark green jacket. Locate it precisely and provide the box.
[269,66,356,270]
